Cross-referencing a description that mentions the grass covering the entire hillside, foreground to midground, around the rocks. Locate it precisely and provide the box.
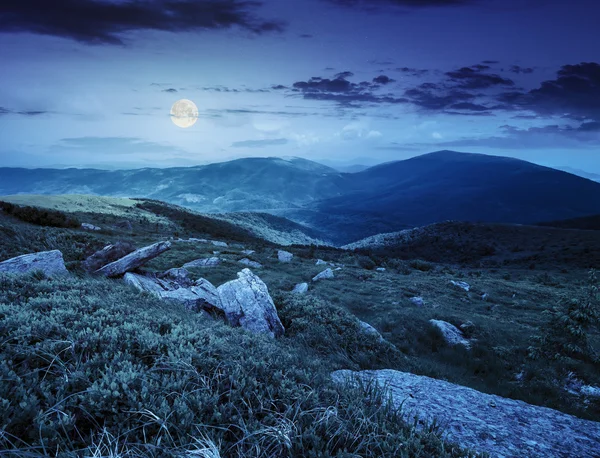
[0,196,600,457]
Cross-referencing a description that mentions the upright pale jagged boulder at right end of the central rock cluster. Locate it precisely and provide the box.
[217,269,284,337]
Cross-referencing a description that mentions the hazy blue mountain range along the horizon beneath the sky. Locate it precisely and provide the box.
[0,151,600,244]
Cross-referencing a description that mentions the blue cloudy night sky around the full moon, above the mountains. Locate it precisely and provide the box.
[0,0,600,173]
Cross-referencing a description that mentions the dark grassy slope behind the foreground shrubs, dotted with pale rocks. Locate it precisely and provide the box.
[0,197,600,456]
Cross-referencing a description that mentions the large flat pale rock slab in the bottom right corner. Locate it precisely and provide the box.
[332,369,600,458]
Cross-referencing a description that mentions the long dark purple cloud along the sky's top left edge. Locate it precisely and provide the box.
[0,0,283,45]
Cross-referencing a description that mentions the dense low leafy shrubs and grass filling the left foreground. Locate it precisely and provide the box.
[0,275,463,458]
